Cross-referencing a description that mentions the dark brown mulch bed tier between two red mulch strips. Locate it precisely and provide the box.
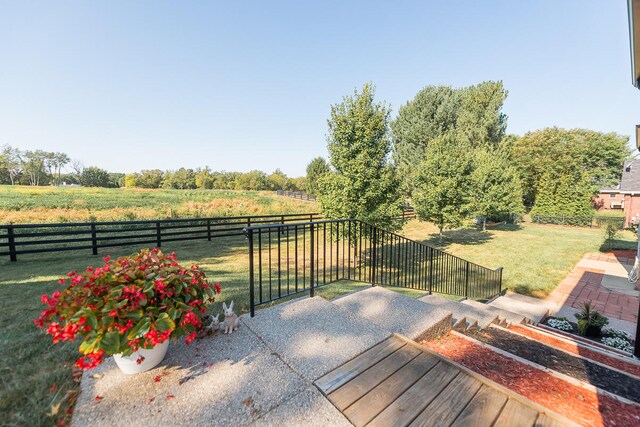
[467,327,640,403]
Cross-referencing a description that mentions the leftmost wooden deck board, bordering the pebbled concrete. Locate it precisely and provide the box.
[316,337,405,394]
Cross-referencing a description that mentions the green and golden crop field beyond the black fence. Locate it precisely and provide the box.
[0,186,315,224]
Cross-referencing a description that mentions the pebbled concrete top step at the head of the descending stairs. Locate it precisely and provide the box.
[331,286,453,341]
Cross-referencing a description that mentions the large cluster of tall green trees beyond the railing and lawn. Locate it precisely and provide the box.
[307,81,631,233]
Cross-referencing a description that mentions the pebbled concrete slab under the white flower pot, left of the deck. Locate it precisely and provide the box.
[73,326,310,426]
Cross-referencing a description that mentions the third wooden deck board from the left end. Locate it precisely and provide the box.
[344,354,438,426]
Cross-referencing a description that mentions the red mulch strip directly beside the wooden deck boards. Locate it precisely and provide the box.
[422,335,640,426]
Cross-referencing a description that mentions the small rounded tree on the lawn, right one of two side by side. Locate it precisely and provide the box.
[471,150,524,231]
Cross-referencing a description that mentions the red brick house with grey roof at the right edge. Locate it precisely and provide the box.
[594,159,640,226]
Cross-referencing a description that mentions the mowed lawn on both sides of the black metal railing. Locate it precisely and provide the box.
[0,219,636,425]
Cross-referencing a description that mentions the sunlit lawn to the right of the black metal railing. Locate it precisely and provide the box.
[401,221,637,298]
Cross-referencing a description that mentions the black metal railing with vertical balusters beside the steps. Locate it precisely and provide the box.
[245,219,502,316]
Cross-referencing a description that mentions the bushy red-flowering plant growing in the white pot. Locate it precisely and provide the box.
[34,249,220,369]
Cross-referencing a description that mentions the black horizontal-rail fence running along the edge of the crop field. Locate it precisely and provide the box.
[0,213,322,261]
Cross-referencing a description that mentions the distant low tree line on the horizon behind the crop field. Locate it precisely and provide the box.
[0,145,306,191]
